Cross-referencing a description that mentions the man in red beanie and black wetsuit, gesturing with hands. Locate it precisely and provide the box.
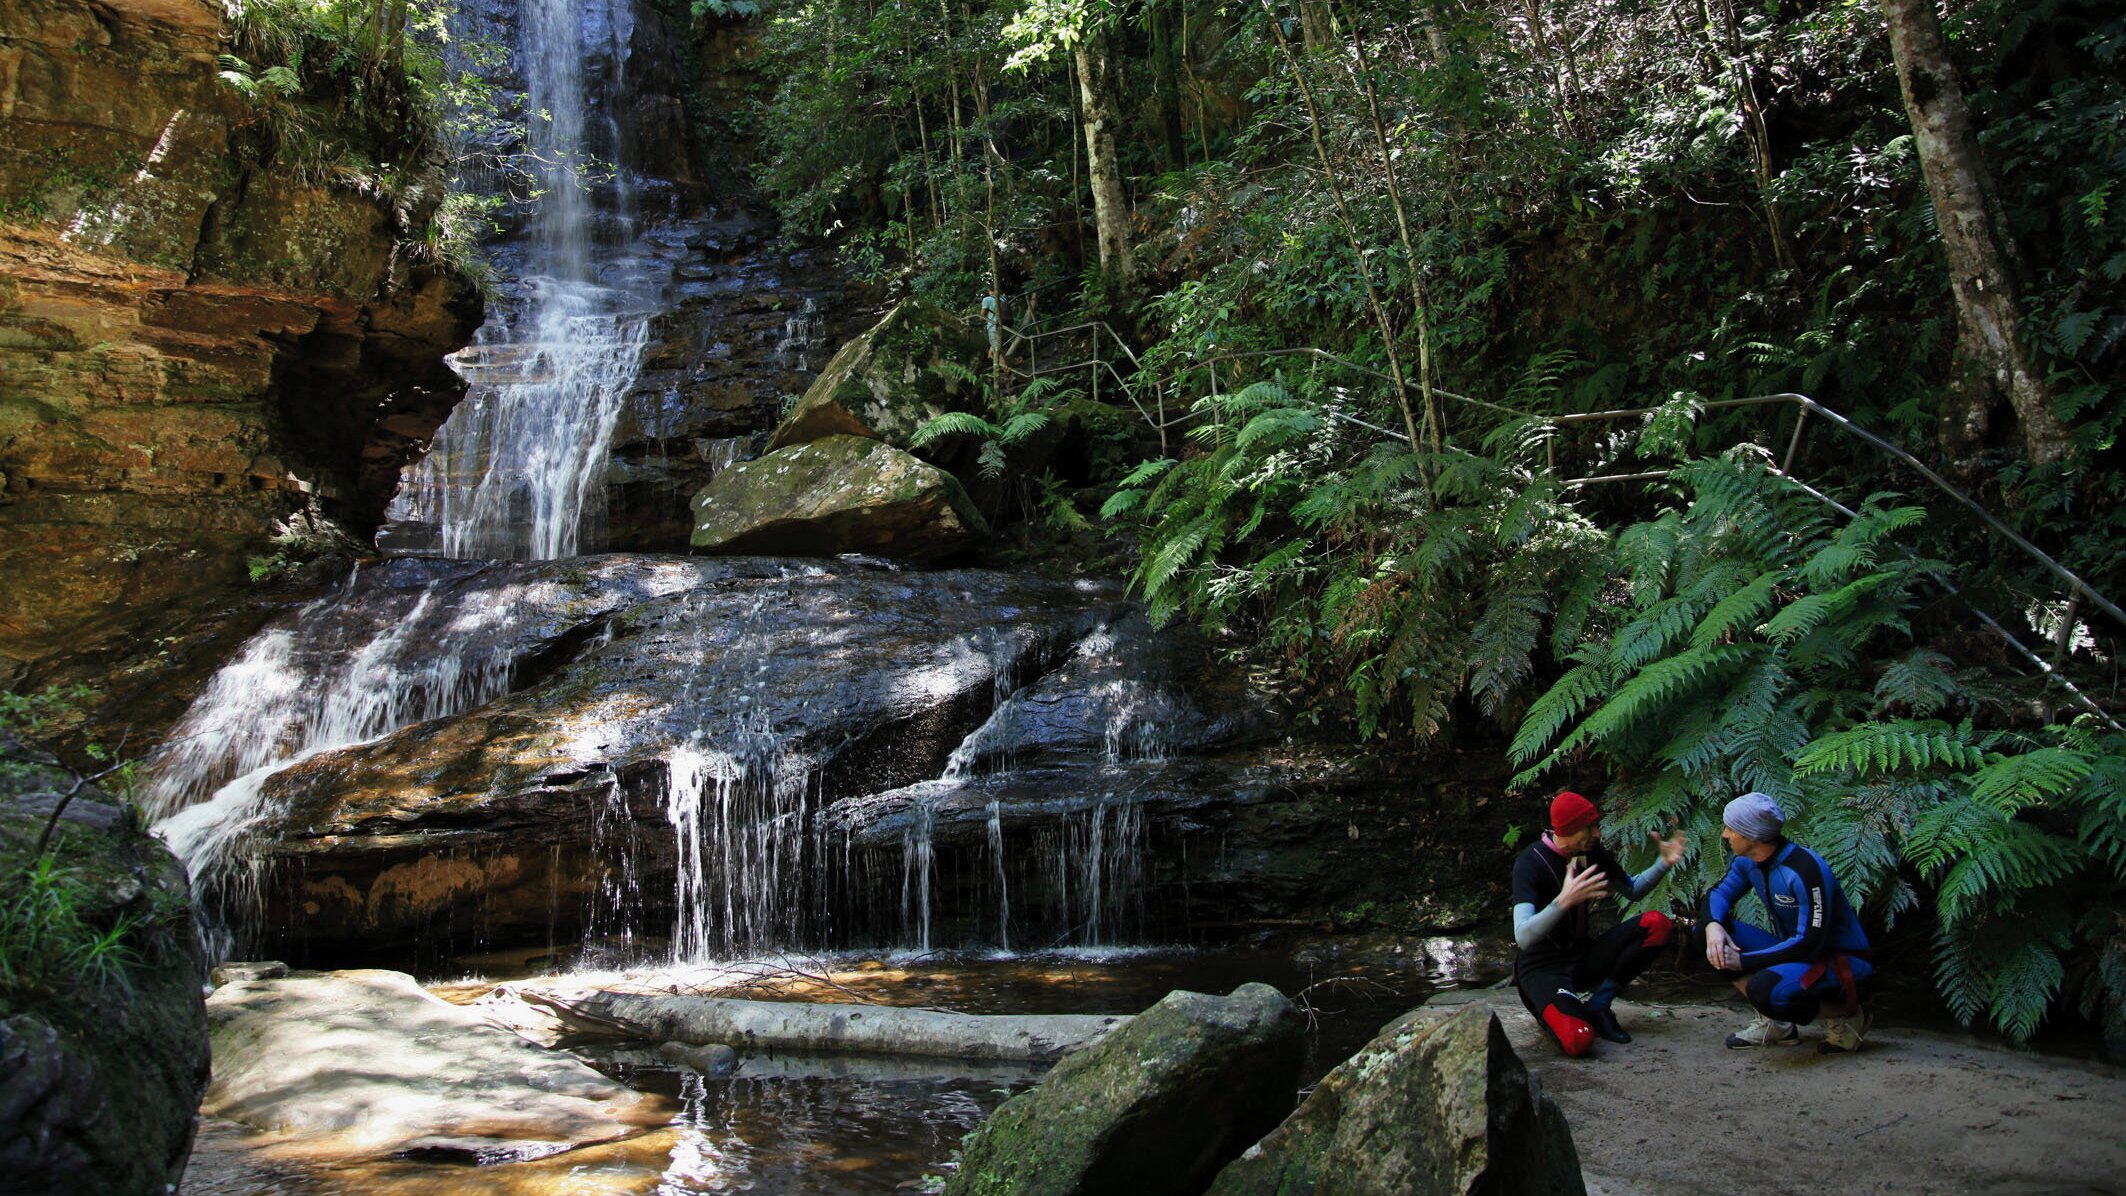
[1514,790,1690,1058]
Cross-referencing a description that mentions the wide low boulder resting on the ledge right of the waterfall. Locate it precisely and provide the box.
[693,435,989,561]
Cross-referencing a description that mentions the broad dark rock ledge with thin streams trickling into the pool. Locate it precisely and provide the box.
[151,554,1499,967]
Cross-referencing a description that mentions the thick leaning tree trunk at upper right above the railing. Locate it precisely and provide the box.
[1882,0,2069,463]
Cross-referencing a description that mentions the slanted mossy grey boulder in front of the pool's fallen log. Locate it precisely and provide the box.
[946,984,1305,1196]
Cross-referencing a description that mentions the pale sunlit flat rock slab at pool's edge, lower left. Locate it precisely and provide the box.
[204,971,672,1164]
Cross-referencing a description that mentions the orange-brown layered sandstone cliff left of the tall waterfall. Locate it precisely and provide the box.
[0,0,478,673]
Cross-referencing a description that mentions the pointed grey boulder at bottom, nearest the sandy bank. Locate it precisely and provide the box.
[1210,1005,1586,1196]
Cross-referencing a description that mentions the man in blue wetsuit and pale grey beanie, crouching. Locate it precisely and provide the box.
[1703,792,1873,1054]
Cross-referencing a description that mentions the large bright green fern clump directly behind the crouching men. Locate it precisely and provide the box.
[1512,452,2126,1039]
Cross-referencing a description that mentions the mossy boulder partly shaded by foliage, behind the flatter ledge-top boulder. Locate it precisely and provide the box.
[767,300,982,452]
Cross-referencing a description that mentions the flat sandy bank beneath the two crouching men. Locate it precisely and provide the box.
[1433,990,2126,1196]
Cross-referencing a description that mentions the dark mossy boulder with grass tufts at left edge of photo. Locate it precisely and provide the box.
[0,737,208,1194]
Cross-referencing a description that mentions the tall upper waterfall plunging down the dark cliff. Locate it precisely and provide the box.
[389,0,651,561]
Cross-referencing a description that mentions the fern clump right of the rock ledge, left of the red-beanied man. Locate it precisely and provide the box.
[1101,380,1603,735]
